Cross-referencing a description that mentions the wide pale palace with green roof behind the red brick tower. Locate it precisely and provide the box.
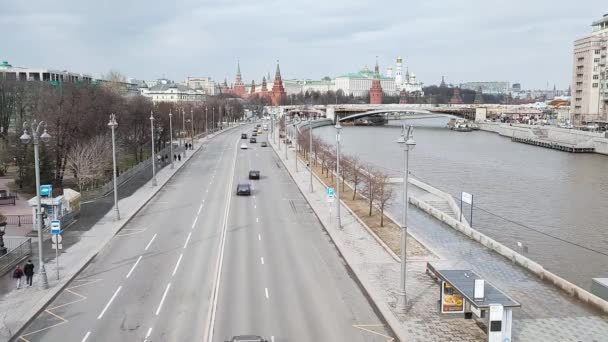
[334,67,399,97]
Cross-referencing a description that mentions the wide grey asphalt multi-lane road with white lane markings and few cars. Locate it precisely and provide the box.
[20,126,389,341]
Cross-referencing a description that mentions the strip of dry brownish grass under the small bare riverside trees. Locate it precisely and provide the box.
[300,153,432,257]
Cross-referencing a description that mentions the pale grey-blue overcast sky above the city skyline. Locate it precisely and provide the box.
[0,0,608,88]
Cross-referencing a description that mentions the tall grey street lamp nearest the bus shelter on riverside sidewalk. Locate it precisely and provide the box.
[397,124,416,311]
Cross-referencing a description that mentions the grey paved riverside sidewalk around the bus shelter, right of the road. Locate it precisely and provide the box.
[269,139,608,341]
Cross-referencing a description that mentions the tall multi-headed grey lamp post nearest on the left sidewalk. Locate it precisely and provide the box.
[19,120,51,289]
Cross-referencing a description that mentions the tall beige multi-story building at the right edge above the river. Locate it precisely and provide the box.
[571,14,608,125]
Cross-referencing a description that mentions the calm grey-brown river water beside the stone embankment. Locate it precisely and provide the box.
[315,118,608,289]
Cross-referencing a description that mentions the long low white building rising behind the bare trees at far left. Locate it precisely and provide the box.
[0,61,93,83]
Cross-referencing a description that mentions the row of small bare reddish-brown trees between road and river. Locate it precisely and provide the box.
[298,130,394,227]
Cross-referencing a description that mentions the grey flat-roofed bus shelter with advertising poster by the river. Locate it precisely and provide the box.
[426,263,521,342]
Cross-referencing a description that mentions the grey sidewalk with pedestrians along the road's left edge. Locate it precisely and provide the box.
[0,130,233,341]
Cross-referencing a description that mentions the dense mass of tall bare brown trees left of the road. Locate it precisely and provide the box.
[0,78,243,194]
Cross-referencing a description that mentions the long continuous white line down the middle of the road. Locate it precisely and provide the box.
[205,136,239,342]
